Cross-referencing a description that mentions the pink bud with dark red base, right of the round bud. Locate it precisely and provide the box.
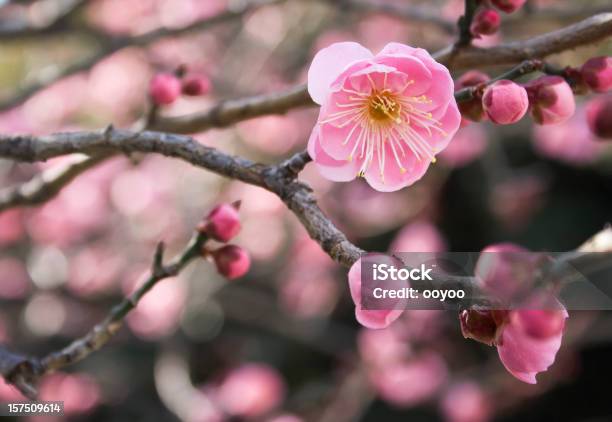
[525,76,576,125]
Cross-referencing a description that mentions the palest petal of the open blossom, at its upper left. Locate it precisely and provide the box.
[308,42,372,104]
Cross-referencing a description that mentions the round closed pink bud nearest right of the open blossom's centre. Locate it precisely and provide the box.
[482,79,529,125]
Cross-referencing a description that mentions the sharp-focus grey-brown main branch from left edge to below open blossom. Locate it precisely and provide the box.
[0,128,362,266]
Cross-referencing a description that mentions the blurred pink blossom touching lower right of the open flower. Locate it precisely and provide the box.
[440,125,487,167]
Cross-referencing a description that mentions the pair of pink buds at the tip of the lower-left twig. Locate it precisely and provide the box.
[198,201,251,280]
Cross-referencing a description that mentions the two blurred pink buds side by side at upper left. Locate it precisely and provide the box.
[149,68,210,106]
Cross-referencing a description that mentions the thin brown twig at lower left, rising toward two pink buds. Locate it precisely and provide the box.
[0,232,206,399]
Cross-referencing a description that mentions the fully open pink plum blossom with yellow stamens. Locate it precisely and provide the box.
[308,42,461,192]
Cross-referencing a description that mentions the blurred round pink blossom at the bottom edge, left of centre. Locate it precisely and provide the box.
[218,363,285,418]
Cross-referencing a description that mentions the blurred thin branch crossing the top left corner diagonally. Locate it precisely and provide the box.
[0,0,284,111]
